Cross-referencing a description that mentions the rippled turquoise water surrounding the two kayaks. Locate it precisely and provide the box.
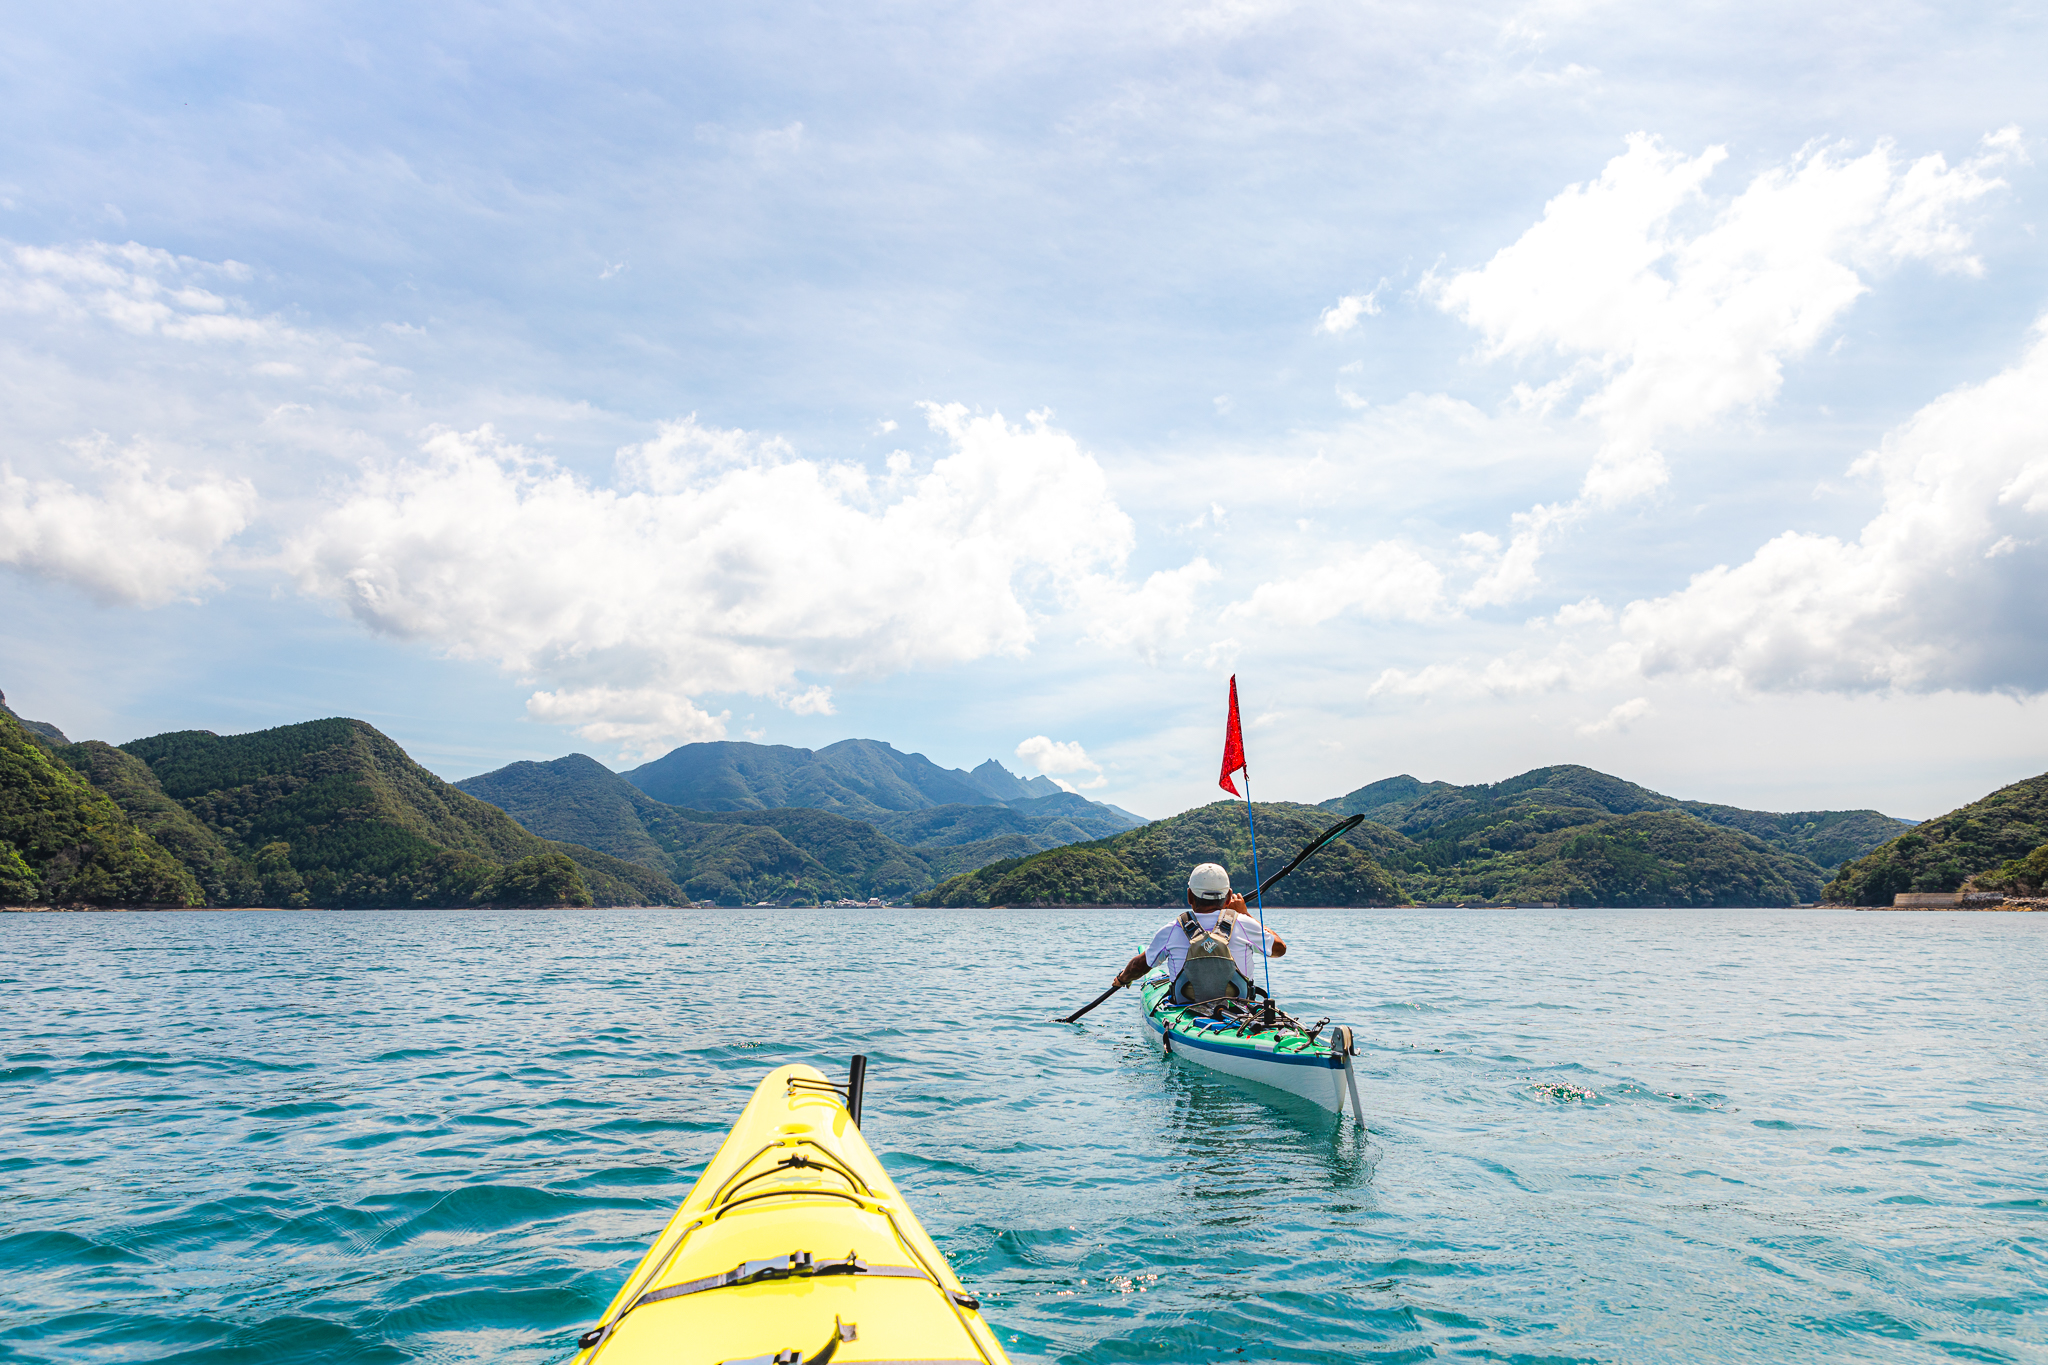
[0,911,2048,1363]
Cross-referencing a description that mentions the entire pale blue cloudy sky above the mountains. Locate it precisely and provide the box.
[0,0,2048,819]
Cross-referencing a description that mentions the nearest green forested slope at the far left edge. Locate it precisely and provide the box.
[0,698,205,907]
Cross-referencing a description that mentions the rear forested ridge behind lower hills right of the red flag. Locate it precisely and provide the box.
[1323,763,1913,872]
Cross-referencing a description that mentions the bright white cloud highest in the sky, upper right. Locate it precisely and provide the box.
[1425,129,2019,505]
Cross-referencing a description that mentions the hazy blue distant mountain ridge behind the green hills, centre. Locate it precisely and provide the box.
[621,739,1145,829]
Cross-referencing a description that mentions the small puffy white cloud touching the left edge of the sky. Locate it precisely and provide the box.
[0,438,256,606]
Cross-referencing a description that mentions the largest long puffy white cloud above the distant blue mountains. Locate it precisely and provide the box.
[285,405,1146,745]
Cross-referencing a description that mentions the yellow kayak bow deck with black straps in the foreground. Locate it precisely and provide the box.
[573,1064,1006,1365]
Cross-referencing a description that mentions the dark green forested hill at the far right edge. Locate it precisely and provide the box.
[1827,774,2048,905]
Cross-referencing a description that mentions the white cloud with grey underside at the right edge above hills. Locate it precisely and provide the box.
[1622,323,2048,692]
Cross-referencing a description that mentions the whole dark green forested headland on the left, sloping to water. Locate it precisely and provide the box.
[0,702,684,909]
